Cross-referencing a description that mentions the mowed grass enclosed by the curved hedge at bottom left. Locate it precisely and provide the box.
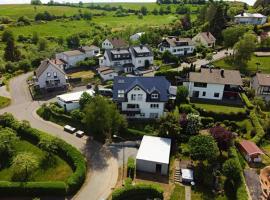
[0,140,72,181]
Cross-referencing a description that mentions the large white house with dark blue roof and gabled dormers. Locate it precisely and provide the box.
[113,76,170,118]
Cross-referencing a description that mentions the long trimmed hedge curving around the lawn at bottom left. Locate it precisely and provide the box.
[0,113,87,195]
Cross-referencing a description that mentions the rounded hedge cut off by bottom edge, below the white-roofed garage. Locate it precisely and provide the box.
[112,184,163,200]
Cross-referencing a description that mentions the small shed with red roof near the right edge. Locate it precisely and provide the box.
[239,140,264,162]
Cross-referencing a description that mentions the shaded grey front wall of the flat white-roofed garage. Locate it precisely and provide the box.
[136,159,168,175]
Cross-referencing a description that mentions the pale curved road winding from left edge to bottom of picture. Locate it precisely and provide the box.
[0,73,118,200]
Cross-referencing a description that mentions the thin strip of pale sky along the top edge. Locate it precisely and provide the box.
[0,0,256,5]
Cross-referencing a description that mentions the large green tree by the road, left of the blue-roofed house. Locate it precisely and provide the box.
[83,95,127,140]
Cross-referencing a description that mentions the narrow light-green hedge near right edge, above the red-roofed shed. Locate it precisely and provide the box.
[249,110,265,145]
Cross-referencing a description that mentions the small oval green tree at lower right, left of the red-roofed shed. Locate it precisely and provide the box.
[222,158,241,183]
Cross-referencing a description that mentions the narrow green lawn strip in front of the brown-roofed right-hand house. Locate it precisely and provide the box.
[193,103,244,113]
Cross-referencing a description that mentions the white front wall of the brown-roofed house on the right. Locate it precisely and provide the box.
[187,82,224,100]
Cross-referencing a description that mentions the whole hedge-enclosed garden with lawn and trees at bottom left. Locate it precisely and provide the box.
[0,113,87,197]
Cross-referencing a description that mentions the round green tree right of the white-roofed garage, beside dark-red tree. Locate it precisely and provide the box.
[188,135,218,162]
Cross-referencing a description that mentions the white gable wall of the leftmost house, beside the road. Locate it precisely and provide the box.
[37,65,67,88]
